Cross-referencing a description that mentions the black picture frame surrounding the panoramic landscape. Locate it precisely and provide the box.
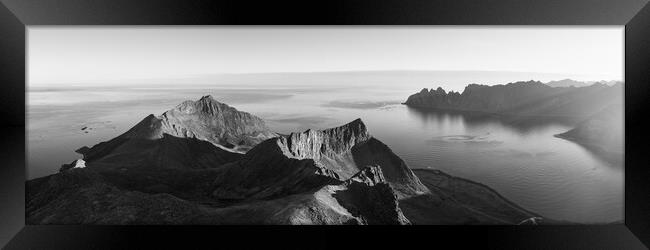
[0,0,650,249]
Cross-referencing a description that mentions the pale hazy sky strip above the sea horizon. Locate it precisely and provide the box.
[28,26,624,86]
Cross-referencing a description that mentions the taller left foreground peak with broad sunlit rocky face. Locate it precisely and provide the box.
[80,95,277,164]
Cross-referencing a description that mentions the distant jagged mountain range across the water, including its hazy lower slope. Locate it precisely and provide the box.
[404,79,625,161]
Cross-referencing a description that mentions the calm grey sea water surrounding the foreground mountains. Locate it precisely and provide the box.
[27,73,624,223]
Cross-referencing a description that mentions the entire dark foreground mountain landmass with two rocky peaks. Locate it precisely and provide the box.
[26,96,540,225]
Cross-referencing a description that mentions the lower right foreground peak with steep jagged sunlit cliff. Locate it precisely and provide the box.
[210,119,428,199]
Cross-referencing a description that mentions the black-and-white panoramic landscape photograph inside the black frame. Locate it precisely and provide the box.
[25,26,625,225]
